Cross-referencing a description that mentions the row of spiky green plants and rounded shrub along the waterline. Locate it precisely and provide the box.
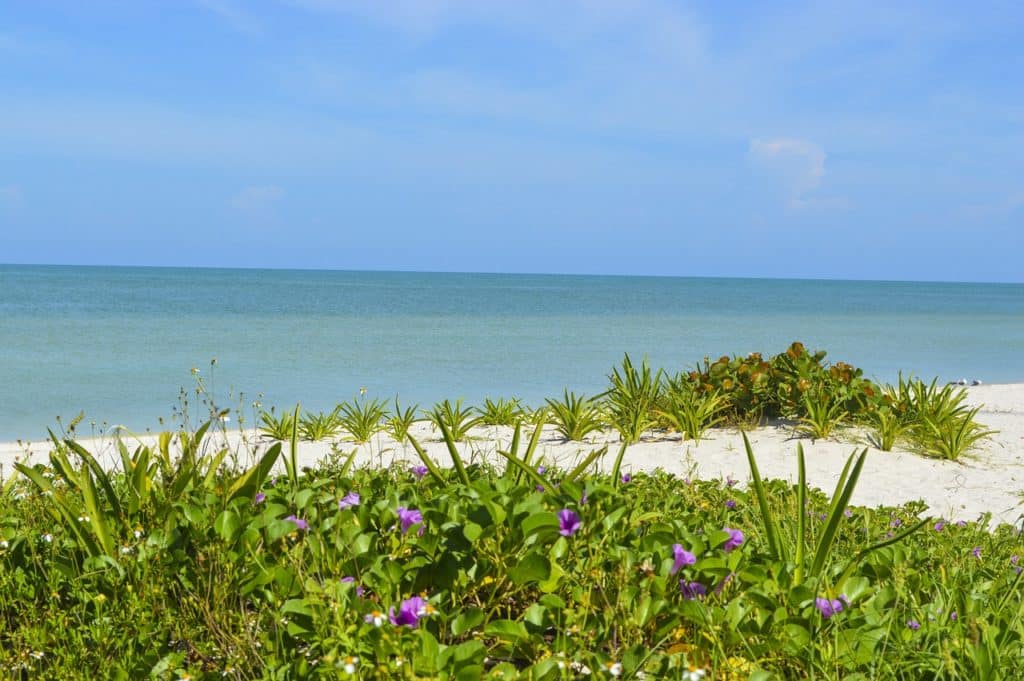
[253,342,992,461]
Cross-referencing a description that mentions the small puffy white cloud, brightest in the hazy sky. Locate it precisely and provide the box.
[749,137,835,209]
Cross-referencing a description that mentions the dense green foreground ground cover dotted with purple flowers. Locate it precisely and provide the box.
[0,411,1024,680]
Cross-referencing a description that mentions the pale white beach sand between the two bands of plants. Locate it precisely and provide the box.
[0,383,1024,523]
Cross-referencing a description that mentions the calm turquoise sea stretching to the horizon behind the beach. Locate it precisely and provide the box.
[0,265,1024,439]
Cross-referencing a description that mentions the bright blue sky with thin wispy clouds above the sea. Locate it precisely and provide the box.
[0,0,1024,282]
